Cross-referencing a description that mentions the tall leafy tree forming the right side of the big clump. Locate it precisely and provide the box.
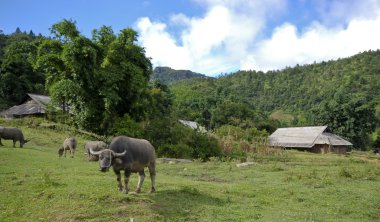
[102,29,152,123]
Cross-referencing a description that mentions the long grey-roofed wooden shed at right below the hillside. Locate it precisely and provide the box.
[269,126,352,154]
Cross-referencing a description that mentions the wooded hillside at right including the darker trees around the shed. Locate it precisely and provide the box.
[171,50,380,149]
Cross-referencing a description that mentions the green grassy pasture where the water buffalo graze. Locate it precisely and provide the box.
[0,120,380,222]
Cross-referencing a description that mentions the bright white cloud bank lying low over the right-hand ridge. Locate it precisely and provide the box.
[243,13,380,70]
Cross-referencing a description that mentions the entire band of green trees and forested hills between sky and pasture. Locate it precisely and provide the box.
[0,20,380,156]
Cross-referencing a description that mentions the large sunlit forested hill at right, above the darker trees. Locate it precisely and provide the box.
[171,50,380,126]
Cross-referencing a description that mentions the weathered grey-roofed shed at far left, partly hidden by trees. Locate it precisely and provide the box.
[0,93,50,118]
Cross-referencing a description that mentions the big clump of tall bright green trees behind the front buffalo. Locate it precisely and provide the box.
[35,20,152,133]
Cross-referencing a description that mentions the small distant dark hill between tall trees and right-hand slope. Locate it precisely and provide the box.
[152,67,210,84]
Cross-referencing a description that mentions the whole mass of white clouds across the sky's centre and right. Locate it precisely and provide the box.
[136,0,380,75]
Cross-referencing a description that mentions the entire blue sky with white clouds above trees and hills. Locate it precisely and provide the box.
[0,0,380,75]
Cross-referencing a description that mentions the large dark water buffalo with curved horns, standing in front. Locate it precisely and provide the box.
[90,136,156,193]
